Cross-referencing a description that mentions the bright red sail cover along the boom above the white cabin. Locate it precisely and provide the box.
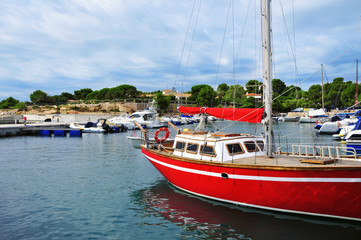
[178,107,264,123]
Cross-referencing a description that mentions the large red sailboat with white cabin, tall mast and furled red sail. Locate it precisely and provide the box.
[141,0,361,221]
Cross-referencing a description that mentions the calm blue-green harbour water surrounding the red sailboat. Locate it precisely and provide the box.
[0,122,361,239]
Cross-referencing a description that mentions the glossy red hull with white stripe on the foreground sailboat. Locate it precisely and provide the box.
[142,148,361,221]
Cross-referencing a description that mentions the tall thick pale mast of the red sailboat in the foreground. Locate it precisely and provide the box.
[261,0,273,157]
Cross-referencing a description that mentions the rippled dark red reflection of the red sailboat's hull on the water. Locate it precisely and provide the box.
[133,180,361,239]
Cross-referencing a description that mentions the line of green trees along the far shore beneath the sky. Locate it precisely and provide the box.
[0,78,361,112]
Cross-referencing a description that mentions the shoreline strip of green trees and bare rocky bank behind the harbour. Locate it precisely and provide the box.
[0,77,361,114]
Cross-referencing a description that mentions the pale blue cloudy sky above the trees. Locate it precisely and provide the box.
[0,0,361,101]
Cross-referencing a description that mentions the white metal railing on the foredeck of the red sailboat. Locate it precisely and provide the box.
[290,145,360,161]
